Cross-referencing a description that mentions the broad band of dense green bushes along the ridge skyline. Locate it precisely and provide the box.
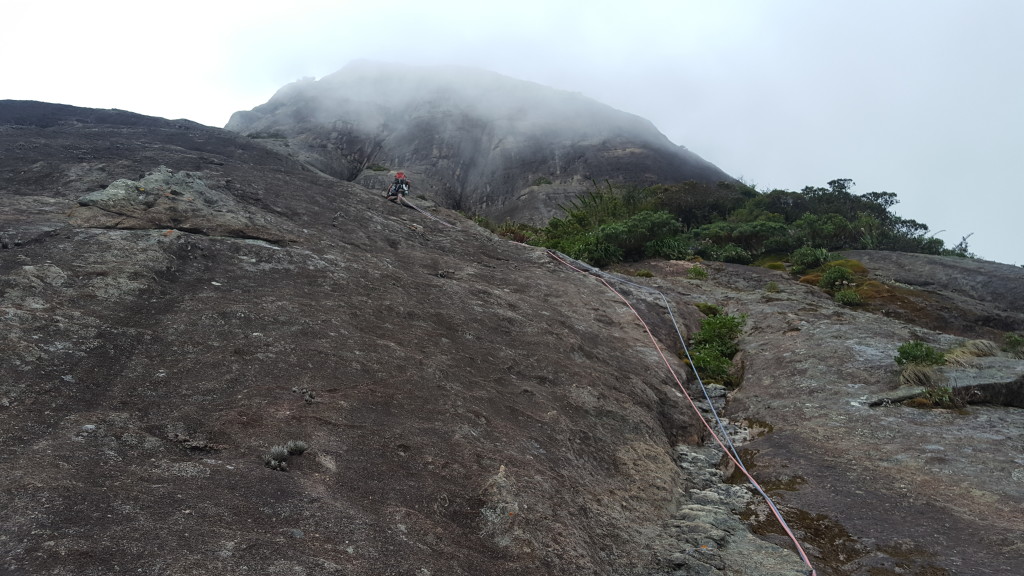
[522,177,971,266]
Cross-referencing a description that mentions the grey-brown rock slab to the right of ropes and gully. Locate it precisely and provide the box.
[610,254,1024,575]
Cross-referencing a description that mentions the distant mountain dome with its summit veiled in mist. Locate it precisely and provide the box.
[226,61,732,223]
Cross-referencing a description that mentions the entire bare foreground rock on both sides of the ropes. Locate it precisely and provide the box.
[0,101,1024,576]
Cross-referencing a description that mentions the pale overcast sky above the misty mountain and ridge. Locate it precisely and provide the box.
[8,0,1024,264]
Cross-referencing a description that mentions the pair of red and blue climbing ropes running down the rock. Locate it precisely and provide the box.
[548,250,817,576]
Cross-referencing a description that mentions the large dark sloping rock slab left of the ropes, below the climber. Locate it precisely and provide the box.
[0,101,804,576]
